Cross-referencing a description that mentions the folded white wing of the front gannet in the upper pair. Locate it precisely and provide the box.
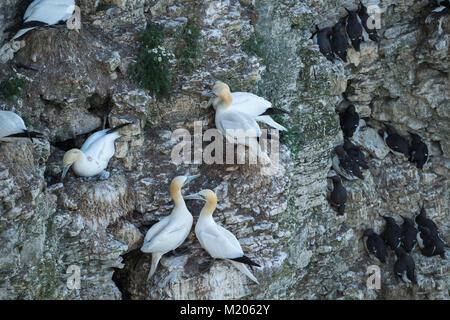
[220,112,262,138]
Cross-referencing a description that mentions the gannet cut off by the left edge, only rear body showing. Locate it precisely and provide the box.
[0,110,43,142]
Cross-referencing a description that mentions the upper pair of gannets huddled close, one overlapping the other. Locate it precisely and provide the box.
[206,81,287,164]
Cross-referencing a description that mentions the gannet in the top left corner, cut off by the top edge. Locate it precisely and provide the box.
[13,0,75,40]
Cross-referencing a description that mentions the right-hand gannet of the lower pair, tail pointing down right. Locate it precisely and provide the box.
[184,189,259,284]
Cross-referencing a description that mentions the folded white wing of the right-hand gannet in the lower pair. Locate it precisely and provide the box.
[197,226,244,259]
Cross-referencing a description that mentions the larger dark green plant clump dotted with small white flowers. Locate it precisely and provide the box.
[128,23,174,97]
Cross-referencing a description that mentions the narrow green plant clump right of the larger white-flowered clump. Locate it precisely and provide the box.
[177,19,202,73]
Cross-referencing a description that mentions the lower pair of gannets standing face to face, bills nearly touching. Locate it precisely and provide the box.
[141,175,259,283]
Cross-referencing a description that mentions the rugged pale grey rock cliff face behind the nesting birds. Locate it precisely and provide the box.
[0,0,450,299]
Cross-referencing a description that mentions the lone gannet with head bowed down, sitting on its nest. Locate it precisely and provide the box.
[61,123,131,180]
